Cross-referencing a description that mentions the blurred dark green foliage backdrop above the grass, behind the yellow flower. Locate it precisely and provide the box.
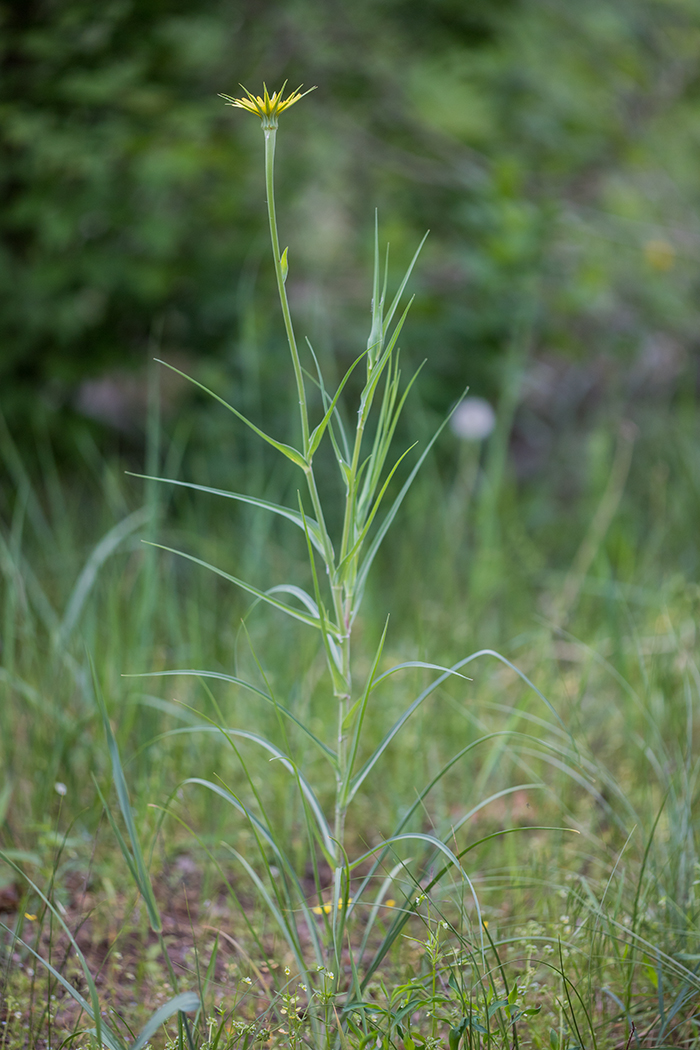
[0,0,700,444]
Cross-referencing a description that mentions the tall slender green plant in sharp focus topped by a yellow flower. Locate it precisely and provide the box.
[128,81,562,1023]
